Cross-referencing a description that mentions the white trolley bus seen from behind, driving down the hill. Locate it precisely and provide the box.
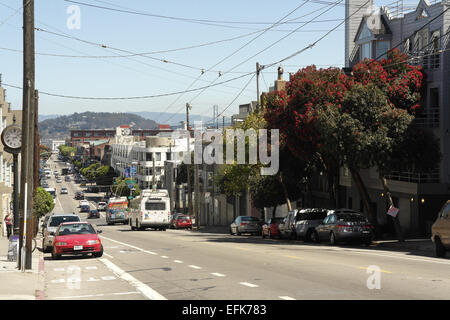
[130,189,170,231]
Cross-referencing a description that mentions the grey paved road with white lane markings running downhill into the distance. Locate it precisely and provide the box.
[40,155,450,300]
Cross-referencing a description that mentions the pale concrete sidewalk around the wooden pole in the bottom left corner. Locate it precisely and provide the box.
[0,237,44,300]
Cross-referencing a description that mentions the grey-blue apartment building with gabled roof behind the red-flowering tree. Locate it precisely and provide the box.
[340,0,450,235]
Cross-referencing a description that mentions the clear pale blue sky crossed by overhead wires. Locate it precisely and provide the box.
[0,0,414,123]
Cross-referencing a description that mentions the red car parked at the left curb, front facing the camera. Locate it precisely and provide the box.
[52,221,103,260]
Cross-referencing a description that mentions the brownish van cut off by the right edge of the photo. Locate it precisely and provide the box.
[431,200,450,258]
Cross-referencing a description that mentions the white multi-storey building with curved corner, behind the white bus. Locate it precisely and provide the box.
[111,132,194,189]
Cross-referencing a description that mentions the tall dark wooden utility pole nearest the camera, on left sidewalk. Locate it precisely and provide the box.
[18,0,35,270]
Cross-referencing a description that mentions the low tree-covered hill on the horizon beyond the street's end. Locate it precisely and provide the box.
[39,112,158,139]
